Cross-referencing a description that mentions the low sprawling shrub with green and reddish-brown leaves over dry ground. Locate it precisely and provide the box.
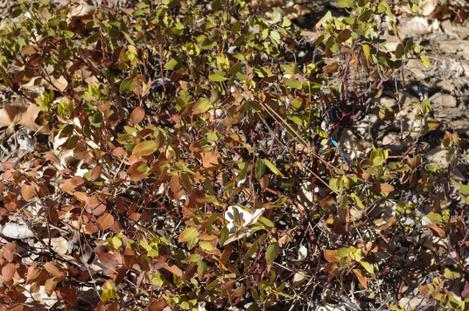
[0,0,469,310]
